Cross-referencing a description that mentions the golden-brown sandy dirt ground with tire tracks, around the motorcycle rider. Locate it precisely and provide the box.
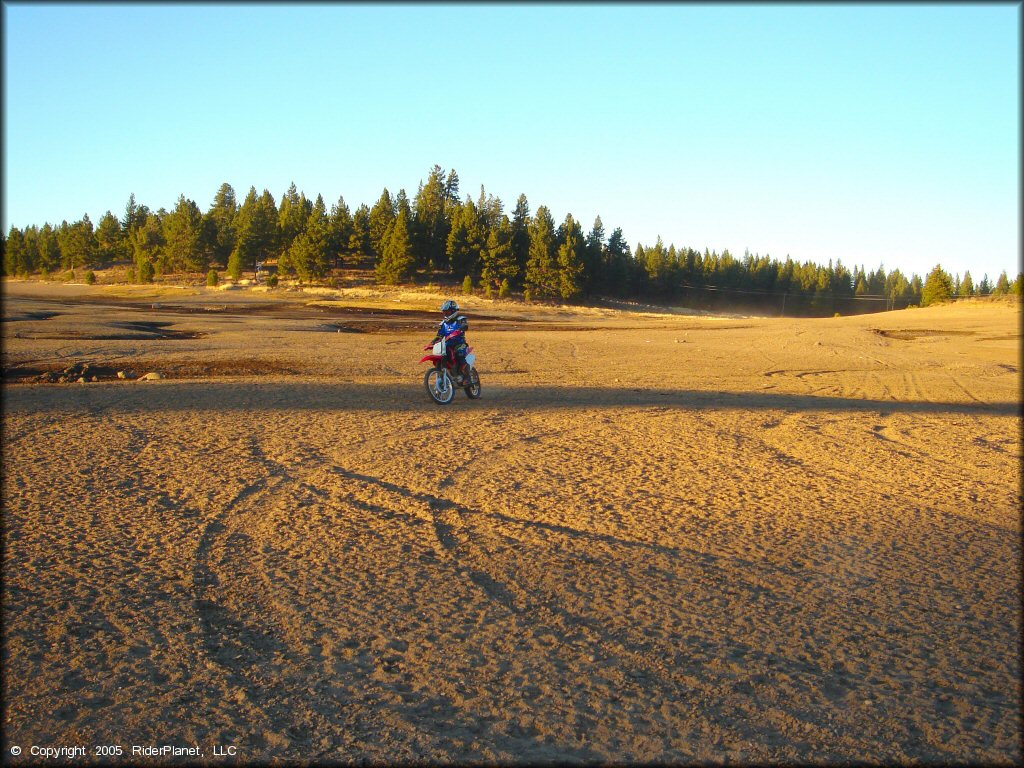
[2,282,1022,764]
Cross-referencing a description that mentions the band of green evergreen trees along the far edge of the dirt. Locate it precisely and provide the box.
[0,165,1021,314]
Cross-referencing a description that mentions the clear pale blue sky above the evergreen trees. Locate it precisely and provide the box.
[3,3,1021,282]
